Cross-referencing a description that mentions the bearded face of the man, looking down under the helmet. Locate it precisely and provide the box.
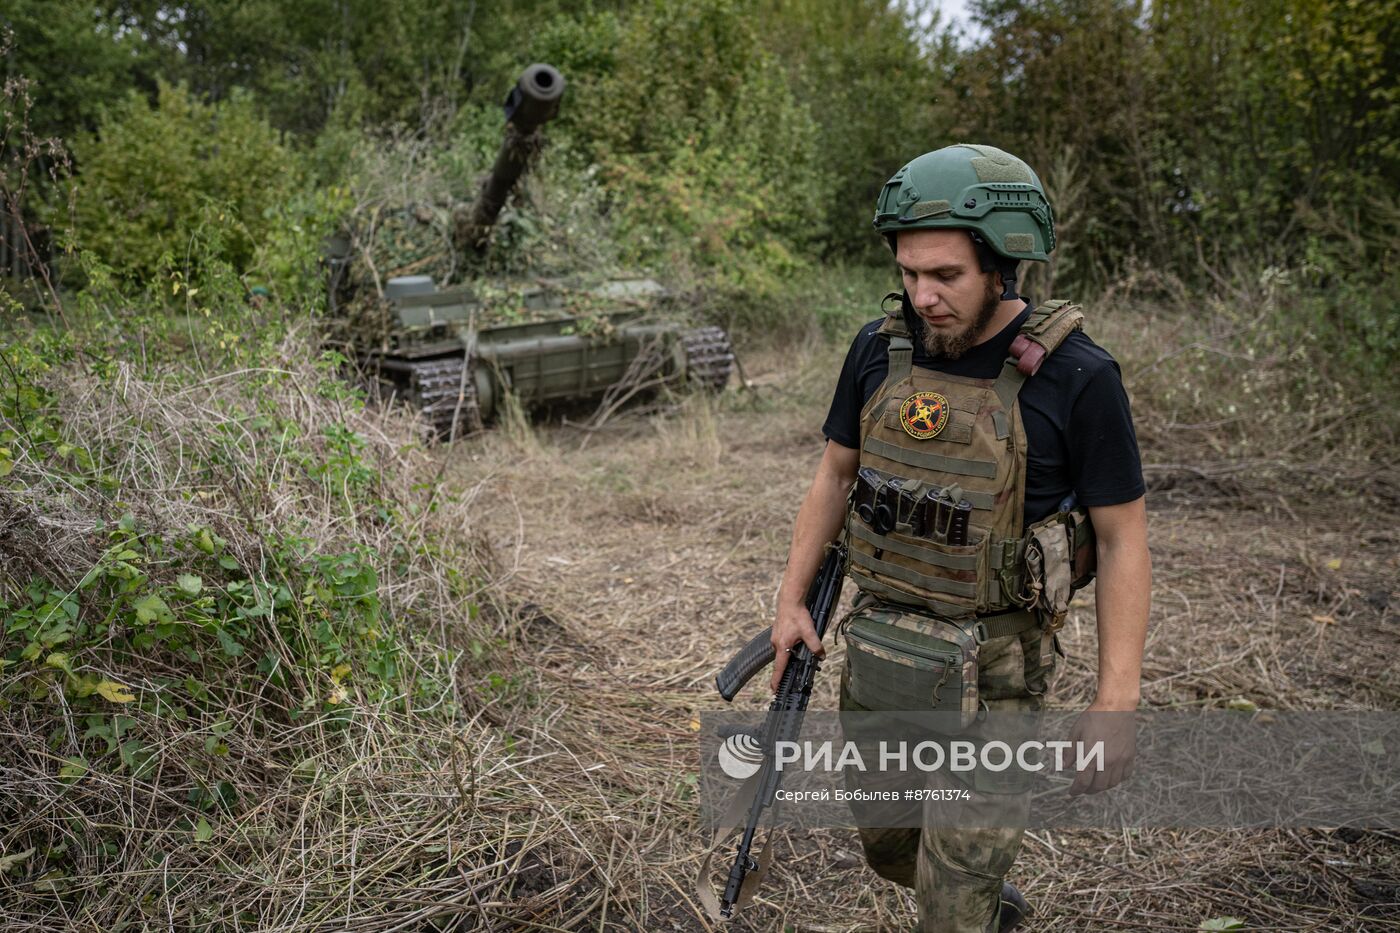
[895,230,1001,360]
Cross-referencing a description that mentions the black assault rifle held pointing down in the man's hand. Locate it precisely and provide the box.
[700,541,846,919]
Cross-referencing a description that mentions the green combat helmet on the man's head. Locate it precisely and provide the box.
[875,143,1054,298]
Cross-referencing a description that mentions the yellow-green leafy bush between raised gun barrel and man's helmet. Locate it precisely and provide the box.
[535,0,833,296]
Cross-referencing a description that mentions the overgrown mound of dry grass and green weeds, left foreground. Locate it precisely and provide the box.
[0,316,515,929]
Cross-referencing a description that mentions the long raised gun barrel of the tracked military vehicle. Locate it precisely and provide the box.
[452,64,564,256]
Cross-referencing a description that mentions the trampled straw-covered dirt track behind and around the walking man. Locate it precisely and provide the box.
[452,350,1400,930]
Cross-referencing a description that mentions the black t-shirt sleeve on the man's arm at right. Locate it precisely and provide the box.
[1067,363,1147,506]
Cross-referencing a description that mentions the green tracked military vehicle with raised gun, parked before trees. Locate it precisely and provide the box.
[329,64,735,437]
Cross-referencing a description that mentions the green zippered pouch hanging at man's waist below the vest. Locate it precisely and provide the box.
[843,607,979,731]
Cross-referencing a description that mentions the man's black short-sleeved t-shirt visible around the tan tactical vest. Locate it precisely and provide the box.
[822,295,1147,525]
